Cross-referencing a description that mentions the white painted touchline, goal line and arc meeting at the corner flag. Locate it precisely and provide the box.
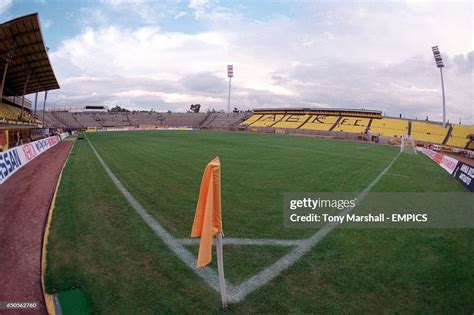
[85,136,401,303]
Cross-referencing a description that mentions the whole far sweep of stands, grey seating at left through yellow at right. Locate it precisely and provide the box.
[34,103,474,148]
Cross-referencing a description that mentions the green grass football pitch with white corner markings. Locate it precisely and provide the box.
[46,131,474,313]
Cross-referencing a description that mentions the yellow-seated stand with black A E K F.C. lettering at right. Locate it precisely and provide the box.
[241,108,474,148]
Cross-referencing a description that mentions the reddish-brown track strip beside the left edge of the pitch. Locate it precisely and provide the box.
[0,142,73,314]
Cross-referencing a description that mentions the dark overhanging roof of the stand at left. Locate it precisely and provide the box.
[0,13,59,95]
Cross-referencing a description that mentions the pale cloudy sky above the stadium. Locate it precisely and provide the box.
[0,0,474,124]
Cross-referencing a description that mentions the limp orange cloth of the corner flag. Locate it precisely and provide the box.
[191,157,222,268]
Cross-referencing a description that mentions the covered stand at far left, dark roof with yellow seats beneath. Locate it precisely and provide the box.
[0,13,59,128]
